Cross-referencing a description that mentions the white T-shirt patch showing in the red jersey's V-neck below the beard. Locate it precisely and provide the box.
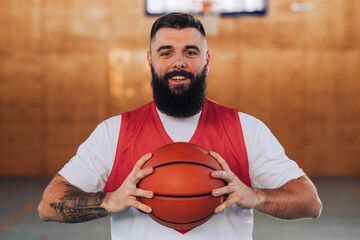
[156,108,201,142]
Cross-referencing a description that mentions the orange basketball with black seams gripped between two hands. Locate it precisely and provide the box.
[139,143,225,230]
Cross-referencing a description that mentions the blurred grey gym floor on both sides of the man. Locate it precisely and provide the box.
[0,179,360,240]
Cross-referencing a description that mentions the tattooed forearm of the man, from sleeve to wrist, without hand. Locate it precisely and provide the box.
[38,176,109,223]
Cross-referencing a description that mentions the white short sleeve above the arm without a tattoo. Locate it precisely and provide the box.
[239,113,304,189]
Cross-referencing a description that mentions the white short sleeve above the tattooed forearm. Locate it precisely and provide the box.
[59,116,121,192]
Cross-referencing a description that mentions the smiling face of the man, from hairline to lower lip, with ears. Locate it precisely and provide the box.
[147,28,210,94]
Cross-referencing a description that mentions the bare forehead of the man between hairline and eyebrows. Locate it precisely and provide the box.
[150,28,206,49]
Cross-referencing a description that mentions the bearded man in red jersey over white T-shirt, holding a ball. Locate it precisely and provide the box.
[38,13,322,240]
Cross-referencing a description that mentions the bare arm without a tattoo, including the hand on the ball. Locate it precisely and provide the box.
[211,152,322,219]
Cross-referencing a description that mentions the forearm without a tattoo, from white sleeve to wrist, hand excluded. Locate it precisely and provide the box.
[254,177,322,219]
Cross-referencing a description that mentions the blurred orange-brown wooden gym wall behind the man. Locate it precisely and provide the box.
[0,0,360,177]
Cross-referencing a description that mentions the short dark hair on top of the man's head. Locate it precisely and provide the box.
[150,12,206,41]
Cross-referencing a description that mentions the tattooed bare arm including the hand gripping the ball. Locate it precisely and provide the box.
[38,154,153,223]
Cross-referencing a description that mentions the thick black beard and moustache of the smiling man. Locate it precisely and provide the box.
[151,66,207,118]
